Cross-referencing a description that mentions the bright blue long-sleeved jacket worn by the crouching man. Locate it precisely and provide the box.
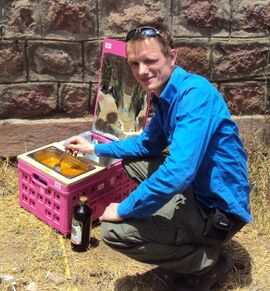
[95,67,252,222]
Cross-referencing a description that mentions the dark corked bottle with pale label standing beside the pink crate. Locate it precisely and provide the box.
[71,196,92,252]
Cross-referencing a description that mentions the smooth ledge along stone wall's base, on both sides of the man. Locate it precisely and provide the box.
[0,115,270,157]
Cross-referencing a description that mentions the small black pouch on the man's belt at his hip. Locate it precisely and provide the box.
[204,208,233,241]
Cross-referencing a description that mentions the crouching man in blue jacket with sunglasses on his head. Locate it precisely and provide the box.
[67,26,251,291]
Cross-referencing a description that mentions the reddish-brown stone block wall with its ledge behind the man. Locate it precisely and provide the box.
[0,0,270,156]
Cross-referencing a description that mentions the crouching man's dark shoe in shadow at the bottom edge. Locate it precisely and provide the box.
[173,254,233,291]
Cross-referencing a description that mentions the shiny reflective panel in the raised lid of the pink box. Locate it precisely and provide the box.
[93,40,148,139]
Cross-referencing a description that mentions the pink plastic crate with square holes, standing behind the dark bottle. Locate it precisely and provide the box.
[18,160,137,235]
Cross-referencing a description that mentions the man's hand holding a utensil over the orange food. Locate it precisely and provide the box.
[66,135,95,156]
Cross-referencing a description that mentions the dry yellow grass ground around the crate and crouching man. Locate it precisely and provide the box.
[0,140,270,291]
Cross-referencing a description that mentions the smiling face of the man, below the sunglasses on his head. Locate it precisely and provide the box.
[126,37,176,96]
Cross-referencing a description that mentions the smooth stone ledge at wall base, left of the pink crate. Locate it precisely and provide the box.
[0,118,93,157]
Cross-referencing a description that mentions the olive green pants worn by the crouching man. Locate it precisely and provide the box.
[101,156,236,274]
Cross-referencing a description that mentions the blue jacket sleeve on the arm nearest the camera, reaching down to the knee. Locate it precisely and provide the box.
[118,89,214,218]
